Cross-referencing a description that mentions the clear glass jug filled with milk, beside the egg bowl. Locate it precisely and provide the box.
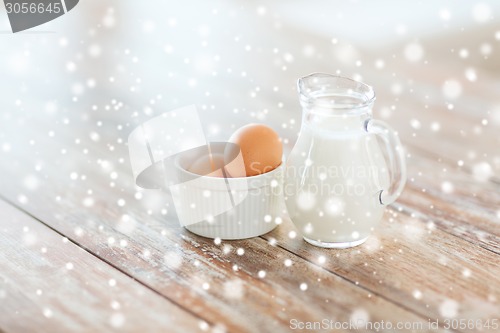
[283,73,406,248]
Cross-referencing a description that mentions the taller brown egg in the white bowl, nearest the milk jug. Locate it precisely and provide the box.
[224,124,283,177]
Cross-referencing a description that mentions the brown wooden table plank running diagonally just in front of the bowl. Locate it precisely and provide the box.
[3,146,442,332]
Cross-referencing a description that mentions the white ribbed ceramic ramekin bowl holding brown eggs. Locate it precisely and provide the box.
[171,142,284,239]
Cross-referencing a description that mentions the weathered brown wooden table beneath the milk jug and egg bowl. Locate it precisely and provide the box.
[0,3,500,333]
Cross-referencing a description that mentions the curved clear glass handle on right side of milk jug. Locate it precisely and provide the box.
[365,119,406,206]
